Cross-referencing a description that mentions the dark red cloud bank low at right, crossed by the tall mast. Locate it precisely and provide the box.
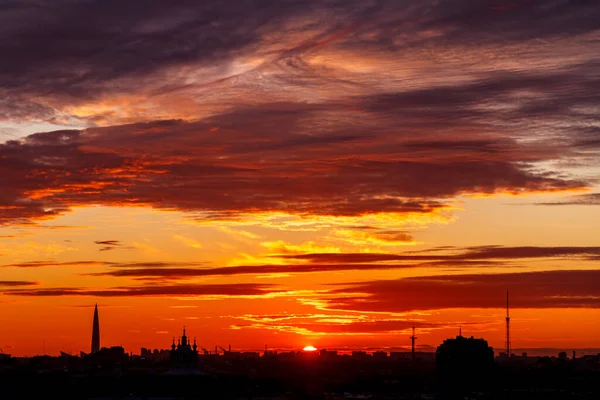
[327,270,600,312]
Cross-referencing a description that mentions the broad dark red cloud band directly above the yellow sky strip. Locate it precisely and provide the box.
[0,111,584,224]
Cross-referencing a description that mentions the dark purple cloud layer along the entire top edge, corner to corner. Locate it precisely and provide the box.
[0,0,600,104]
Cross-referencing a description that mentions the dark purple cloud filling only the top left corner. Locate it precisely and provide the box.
[0,0,341,98]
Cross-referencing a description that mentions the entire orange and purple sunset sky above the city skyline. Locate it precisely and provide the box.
[0,0,600,355]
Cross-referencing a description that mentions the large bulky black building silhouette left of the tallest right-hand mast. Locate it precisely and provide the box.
[435,335,494,397]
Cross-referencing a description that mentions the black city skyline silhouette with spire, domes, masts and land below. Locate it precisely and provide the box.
[0,297,600,400]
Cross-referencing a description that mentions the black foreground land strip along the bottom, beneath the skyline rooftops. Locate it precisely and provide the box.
[0,358,600,400]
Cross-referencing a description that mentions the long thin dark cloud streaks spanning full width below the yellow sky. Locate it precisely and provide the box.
[0,245,600,280]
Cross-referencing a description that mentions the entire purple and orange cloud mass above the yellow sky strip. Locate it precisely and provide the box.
[0,0,600,225]
